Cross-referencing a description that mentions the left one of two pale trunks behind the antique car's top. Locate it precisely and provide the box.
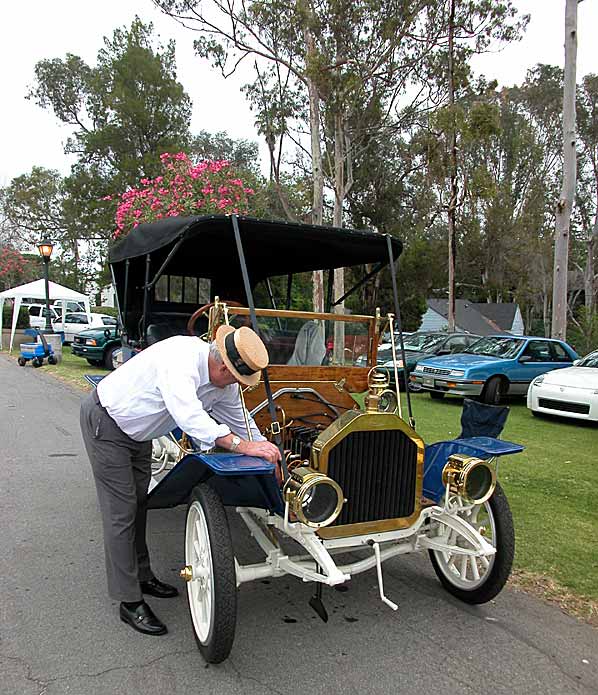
[303,27,324,311]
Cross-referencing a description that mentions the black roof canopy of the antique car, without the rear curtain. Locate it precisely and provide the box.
[109,215,402,284]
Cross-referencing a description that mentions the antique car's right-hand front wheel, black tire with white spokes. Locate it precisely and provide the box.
[429,483,515,604]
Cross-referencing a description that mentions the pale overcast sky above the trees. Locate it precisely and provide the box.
[0,0,598,186]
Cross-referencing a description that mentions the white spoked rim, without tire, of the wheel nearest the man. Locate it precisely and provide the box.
[185,500,214,644]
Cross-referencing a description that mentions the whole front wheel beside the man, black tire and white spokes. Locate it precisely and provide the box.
[185,484,237,664]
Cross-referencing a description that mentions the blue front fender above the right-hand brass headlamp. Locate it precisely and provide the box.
[424,437,524,503]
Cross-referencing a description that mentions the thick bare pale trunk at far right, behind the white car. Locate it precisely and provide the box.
[551,0,577,340]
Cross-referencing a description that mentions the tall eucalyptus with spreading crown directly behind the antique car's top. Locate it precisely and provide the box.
[154,0,446,308]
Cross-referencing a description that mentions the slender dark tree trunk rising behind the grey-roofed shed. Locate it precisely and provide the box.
[447,0,459,332]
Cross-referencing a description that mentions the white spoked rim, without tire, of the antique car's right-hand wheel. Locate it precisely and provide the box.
[434,500,496,591]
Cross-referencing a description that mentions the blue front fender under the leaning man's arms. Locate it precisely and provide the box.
[147,453,284,514]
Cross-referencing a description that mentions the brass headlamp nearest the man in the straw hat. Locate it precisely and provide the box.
[283,462,345,528]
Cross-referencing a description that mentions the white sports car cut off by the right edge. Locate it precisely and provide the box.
[527,350,598,421]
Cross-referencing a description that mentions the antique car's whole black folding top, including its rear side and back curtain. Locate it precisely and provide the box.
[109,215,402,339]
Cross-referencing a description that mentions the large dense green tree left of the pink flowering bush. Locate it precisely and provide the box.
[20,18,191,278]
